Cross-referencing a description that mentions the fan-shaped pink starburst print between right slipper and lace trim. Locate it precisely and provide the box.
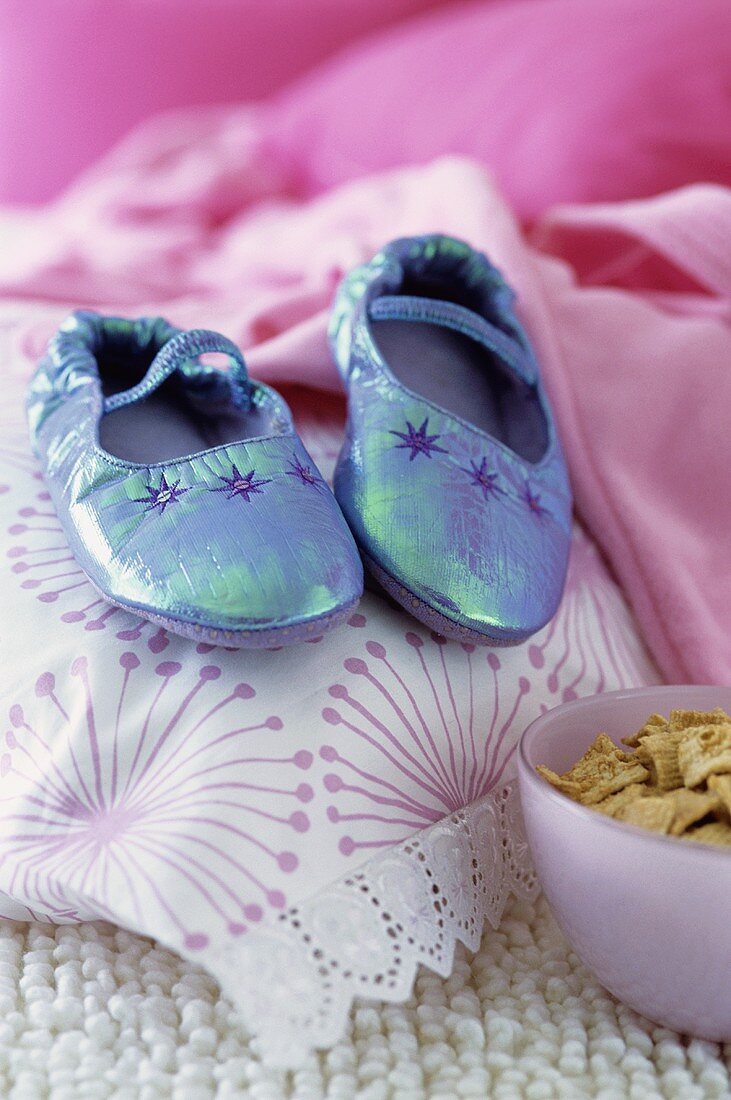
[320,630,531,855]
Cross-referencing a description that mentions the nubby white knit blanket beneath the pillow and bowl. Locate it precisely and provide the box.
[0,900,731,1100]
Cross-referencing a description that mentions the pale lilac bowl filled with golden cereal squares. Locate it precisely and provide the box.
[518,686,731,1042]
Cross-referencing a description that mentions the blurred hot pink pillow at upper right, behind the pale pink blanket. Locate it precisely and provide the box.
[273,0,731,219]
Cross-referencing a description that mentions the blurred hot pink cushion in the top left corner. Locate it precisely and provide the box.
[0,0,450,202]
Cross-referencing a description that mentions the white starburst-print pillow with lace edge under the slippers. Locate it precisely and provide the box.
[0,305,657,1062]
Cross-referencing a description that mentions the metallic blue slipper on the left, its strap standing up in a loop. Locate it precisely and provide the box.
[27,311,363,646]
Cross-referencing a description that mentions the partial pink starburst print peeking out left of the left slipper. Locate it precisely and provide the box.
[5,490,168,653]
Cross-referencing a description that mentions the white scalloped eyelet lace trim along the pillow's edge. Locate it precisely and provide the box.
[207,780,538,1068]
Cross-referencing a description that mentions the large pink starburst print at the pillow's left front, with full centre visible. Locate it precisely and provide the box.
[0,651,313,950]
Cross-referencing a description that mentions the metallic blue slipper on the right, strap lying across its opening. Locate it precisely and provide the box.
[330,235,572,645]
